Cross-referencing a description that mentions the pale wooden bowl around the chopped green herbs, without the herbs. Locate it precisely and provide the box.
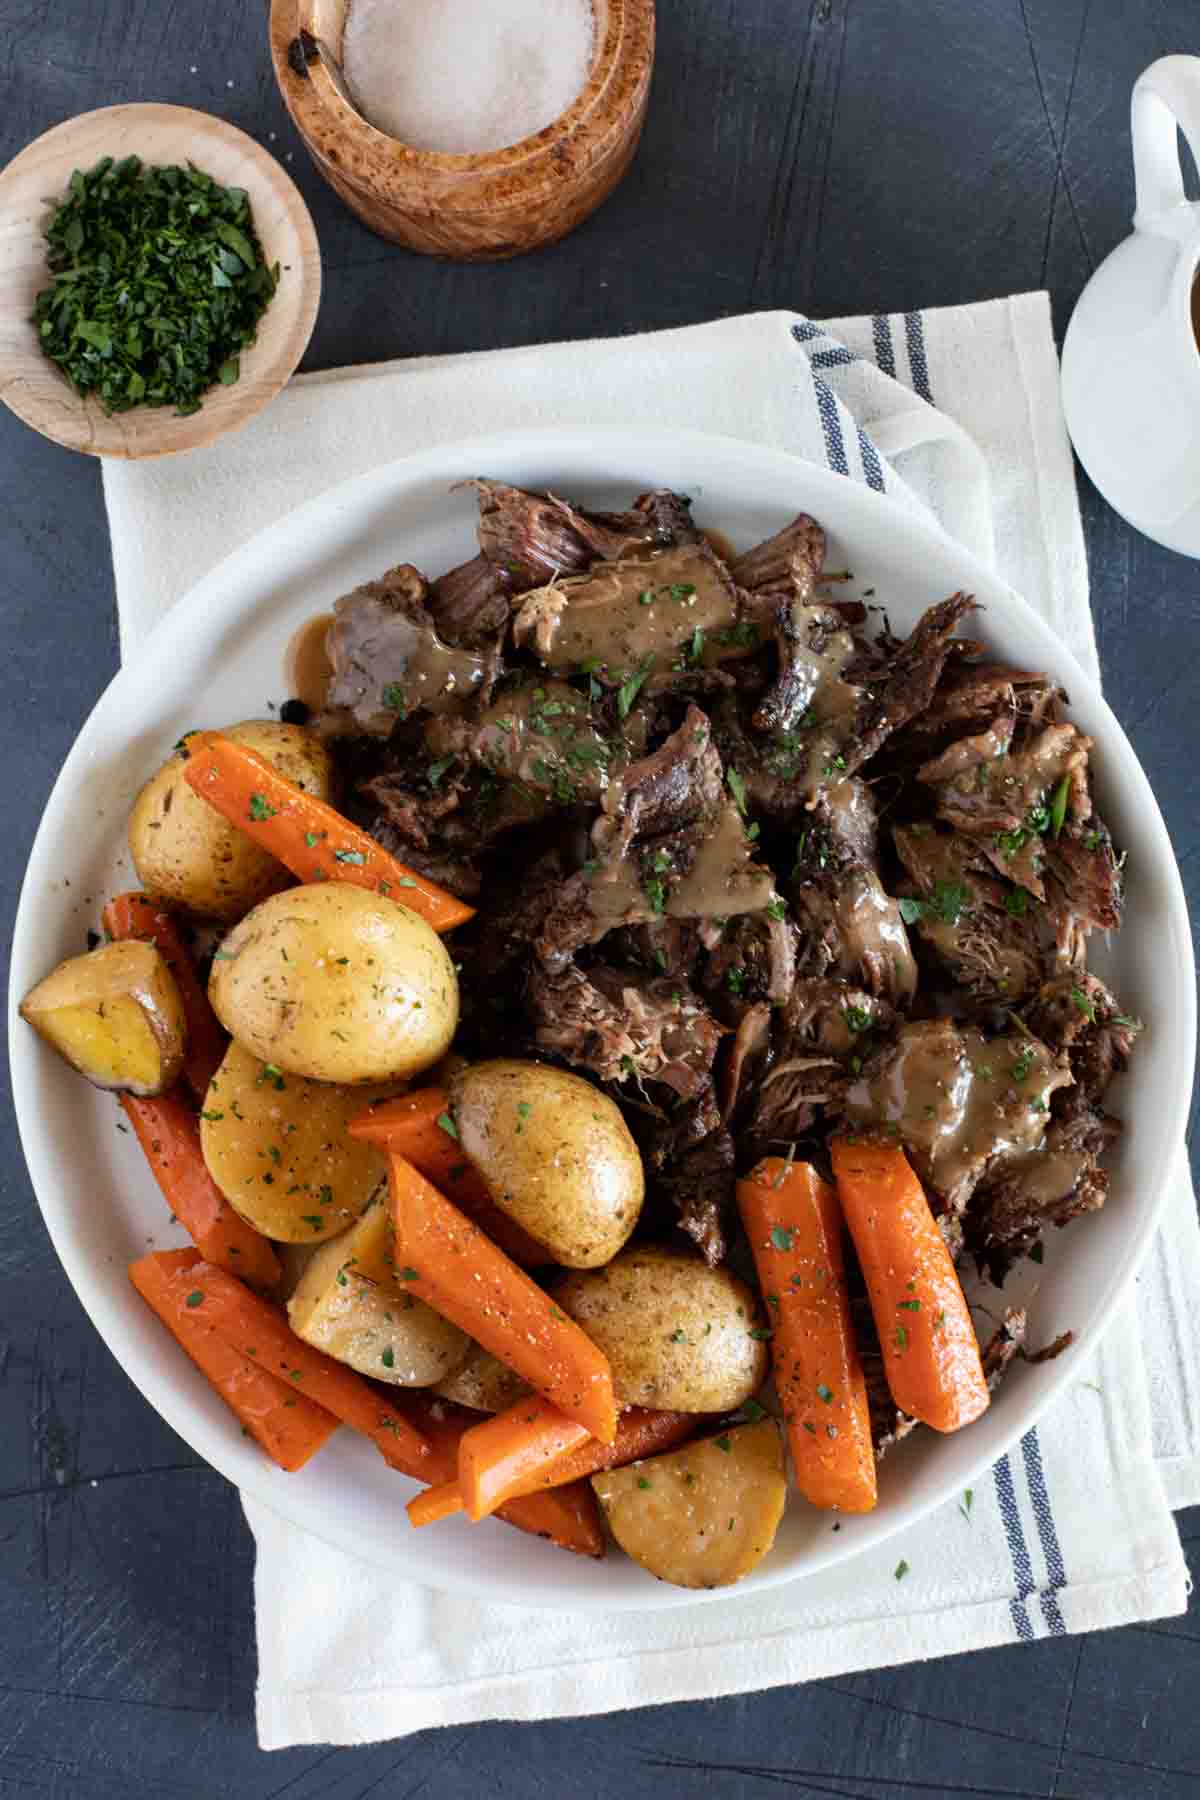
[0,104,320,457]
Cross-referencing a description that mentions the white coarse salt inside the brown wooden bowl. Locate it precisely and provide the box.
[342,0,596,155]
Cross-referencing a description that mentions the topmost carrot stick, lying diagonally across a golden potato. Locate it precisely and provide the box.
[184,731,475,931]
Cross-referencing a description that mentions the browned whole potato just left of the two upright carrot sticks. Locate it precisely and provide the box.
[554,1244,766,1413]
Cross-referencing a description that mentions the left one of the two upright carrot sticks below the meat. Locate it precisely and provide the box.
[738,1156,876,1512]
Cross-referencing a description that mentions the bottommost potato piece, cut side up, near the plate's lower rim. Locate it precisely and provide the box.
[592,1418,788,1588]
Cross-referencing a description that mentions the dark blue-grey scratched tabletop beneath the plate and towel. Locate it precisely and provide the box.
[0,0,1200,1800]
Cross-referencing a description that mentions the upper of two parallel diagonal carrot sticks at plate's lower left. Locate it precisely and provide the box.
[178,1262,426,1463]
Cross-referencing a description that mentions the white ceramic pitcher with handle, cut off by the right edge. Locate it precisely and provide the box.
[1063,56,1200,556]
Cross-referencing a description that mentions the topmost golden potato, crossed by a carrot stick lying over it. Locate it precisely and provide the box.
[130,718,333,922]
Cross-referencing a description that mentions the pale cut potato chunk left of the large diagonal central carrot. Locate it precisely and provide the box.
[288,1204,471,1388]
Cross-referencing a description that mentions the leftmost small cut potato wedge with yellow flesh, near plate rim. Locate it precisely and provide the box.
[20,940,187,1094]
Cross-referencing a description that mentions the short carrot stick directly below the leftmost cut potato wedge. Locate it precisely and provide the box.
[121,1087,279,1287]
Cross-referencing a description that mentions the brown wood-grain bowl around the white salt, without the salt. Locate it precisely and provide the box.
[270,0,655,263]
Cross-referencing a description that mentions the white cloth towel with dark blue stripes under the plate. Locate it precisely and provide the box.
[104,295,1200,1748]
